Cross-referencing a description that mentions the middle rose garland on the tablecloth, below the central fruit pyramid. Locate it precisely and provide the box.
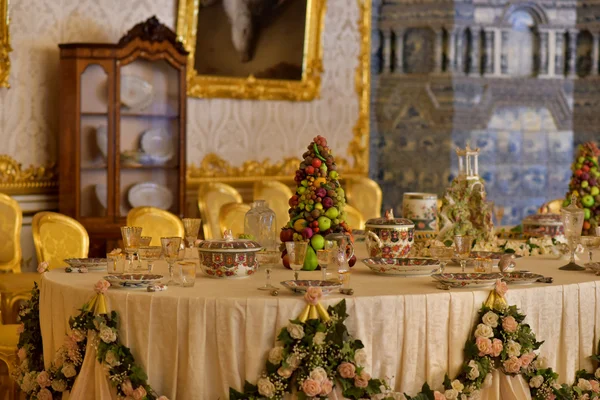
[229,287,399,400]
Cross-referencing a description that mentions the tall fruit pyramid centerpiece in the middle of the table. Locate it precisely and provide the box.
[280,136,352,271]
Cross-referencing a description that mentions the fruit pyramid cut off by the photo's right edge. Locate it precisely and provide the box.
[563,142,600,235]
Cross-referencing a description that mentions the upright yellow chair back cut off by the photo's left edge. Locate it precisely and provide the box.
[0,193,23,273]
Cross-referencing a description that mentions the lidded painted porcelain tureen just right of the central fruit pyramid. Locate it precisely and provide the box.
[365,210,415,258]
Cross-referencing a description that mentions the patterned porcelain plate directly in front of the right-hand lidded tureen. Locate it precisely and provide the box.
[362,257,440,277]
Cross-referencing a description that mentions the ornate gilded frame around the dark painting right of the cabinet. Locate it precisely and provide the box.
[177,0,326,101]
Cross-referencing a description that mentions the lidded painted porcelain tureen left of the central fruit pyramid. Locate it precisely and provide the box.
[198,230,262,278]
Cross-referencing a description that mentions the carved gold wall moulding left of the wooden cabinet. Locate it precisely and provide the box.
[0,155,58,194]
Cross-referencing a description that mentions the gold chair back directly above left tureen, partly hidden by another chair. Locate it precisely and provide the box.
[198,182,242,239]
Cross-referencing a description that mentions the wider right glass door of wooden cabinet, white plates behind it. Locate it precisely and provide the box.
[117,59,181,217]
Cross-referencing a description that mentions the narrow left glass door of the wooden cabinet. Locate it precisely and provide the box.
[79,64,109,217]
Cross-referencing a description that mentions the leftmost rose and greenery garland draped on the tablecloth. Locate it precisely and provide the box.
[13,263,168,400]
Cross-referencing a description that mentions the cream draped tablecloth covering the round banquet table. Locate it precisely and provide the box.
[40,245,600,400]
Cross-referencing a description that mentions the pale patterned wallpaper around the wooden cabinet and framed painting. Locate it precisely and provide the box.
[0,0,360,166]
